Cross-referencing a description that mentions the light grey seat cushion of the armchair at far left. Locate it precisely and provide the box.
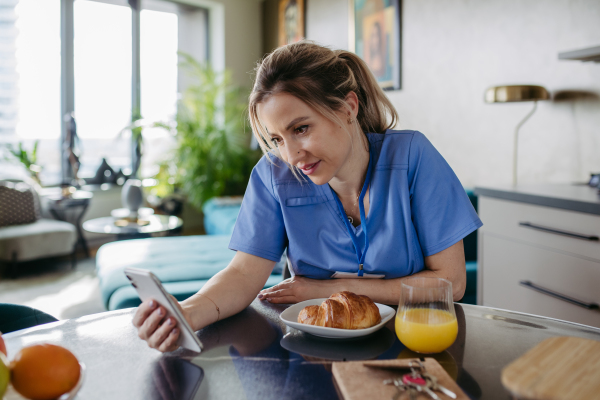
[0,218,77,261]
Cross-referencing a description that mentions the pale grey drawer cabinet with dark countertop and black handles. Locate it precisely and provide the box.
[475,185,600,327]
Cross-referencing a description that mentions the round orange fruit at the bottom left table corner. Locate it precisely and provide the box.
[10,344,80,400]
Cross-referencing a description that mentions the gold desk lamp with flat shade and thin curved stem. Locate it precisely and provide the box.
[485,85,550,186]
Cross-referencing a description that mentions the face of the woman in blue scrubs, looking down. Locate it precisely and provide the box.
[258,93,354,185]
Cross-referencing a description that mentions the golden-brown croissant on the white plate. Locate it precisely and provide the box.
[298,292,381,329]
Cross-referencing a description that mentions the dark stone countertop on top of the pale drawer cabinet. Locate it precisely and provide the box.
[474,184,600,215]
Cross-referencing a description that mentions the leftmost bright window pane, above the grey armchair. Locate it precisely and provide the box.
[0,0,61,181]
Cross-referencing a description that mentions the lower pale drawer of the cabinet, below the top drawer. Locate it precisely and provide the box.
[480,233,600,327]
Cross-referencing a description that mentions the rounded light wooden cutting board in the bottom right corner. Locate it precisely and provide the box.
[502,336,600,400]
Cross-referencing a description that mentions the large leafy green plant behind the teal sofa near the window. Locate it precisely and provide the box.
[149,53,261,209]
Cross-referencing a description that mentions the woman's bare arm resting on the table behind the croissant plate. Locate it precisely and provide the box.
[258,240,467,305]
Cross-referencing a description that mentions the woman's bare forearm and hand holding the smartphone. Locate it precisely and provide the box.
[132,251,275,352]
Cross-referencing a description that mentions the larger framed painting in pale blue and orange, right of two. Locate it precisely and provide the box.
[349,0,402,90]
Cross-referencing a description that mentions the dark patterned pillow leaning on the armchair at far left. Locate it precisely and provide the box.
[0,181,40,227]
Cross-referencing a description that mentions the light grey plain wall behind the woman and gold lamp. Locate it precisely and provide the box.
[270,0,600,186]
